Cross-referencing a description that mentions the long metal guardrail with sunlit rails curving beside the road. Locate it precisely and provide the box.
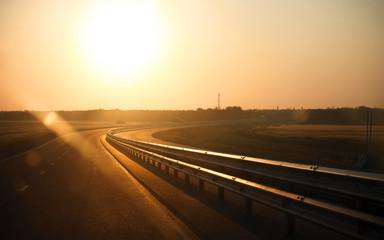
[107,128,384,239]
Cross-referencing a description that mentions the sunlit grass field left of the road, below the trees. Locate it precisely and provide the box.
[0,121,123,159]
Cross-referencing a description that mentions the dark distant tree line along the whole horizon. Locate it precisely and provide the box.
[0,106,384,125]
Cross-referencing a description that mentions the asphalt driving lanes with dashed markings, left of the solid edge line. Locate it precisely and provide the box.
[0,130,196,239]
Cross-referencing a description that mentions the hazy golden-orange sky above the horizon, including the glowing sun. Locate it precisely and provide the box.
[0,0,384,110]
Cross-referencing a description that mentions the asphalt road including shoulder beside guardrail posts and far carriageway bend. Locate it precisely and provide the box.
[0,126,352,239]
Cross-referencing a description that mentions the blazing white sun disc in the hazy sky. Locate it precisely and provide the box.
[79,0,165,77]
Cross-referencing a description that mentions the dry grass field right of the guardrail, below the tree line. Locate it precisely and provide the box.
[154,123,384,172]
